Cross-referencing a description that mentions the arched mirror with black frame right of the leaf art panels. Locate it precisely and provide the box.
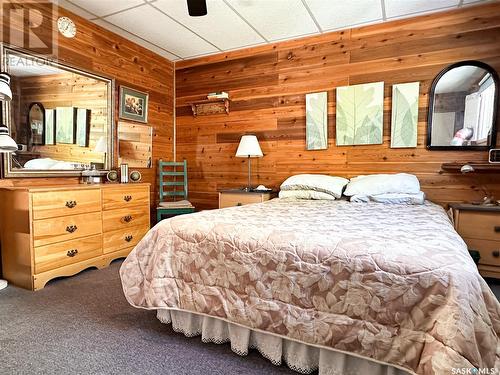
[427,61,498,150]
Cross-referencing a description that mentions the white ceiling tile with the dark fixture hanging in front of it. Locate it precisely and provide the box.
[153,0,264,50]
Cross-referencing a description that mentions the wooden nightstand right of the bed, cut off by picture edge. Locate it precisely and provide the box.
[450,204,500,279]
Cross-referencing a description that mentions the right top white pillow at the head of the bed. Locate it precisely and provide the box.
[344,173,420,196]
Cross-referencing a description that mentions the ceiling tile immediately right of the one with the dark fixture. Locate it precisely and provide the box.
[226,0,319,40]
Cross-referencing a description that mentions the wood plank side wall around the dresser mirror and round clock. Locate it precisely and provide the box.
[0,1,174,209]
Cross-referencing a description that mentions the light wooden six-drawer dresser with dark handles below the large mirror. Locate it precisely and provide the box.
[0,184,150,290]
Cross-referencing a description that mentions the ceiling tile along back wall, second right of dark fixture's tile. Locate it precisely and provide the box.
[305,0,383,30]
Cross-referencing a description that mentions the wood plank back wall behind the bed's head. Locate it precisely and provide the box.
[176,2,500,212]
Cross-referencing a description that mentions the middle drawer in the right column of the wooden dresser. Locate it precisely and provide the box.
[102,205,149,232]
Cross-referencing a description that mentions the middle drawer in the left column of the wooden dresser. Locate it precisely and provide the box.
[33,212,102,247]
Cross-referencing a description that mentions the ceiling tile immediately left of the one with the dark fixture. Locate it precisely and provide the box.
[105,5,218,57]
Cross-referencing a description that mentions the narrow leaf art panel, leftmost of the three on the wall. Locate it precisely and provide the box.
[306,91,328,150]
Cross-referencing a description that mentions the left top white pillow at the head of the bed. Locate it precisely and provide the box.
[280,174,349,198]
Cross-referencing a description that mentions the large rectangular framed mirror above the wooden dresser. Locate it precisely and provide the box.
[2,46,113,177]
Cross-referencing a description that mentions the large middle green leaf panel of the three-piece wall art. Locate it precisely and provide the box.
[336,82,384,146]
